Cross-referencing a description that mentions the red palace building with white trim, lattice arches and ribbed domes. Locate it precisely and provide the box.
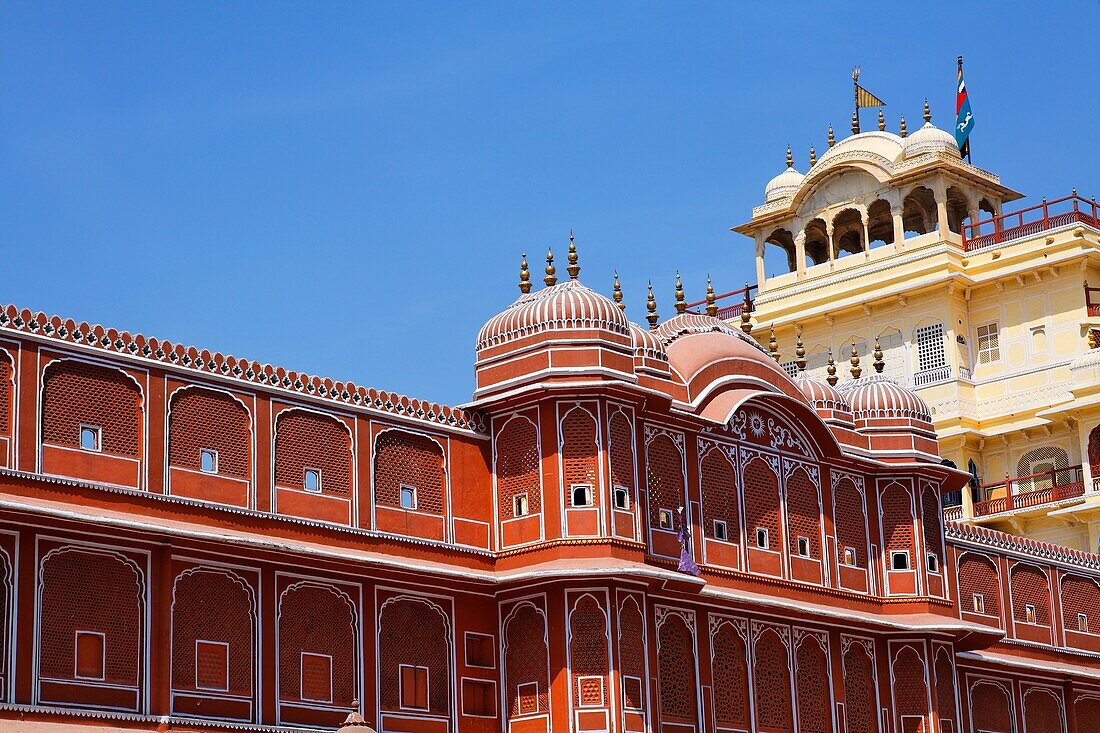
[0,244,1100,733]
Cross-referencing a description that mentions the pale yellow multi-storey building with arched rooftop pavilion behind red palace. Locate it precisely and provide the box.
[725,105,1100,551]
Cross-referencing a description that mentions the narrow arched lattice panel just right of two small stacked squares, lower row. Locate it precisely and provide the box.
[504,603,550,718]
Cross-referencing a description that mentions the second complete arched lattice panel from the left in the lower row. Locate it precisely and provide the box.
[172,568,255,698]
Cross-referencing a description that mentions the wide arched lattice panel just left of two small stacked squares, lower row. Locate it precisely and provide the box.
[378,597,451,715]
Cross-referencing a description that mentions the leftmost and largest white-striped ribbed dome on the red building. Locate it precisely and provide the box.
[476,280,629,351]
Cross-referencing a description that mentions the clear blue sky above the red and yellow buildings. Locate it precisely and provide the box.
[0,0,1100,404]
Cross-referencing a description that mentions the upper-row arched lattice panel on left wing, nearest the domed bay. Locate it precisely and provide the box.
[374,430,447,514]
